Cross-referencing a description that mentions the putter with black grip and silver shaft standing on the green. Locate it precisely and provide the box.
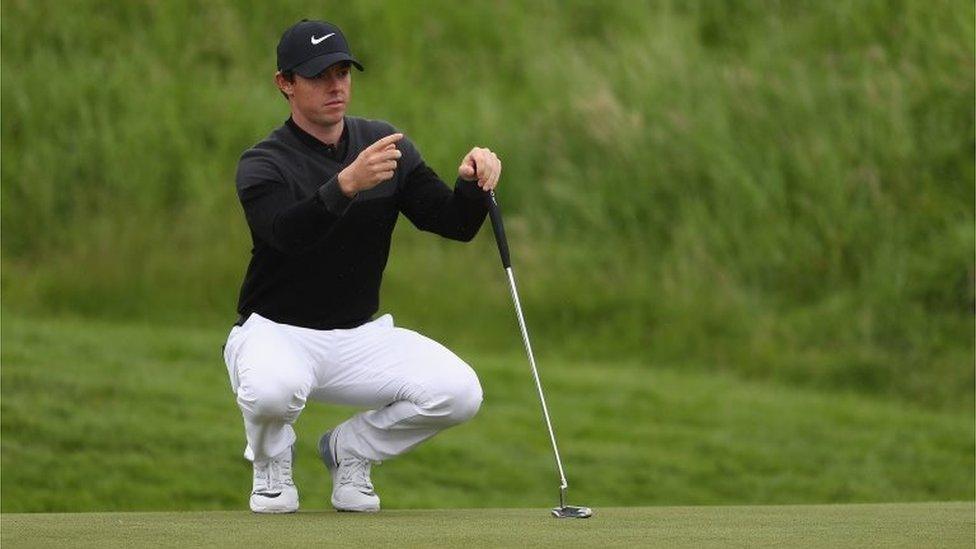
[486,191,593,518]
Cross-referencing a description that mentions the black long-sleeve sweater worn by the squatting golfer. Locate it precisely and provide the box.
[237,116,487,330]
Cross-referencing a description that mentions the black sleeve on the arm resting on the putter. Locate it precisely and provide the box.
[397,161,488,242]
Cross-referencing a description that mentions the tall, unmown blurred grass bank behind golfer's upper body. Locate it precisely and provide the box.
[0,0,976,410]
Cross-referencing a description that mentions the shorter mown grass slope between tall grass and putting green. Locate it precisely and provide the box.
[0,313,974,512]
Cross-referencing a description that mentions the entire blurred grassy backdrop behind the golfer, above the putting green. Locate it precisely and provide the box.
[0,0,976,511]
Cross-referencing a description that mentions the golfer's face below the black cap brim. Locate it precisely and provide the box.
[282,62,352,126]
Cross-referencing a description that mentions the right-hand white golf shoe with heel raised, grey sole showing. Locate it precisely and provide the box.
[319,430,380,513]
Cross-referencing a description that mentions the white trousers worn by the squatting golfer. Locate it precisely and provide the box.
[224,314,482,461]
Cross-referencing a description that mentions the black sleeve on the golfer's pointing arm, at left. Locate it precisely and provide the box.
[237,155,352,254]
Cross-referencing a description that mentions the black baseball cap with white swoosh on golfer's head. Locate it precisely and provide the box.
[278,19,363,78]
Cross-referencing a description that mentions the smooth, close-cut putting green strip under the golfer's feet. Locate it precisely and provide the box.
[0,502,976,547]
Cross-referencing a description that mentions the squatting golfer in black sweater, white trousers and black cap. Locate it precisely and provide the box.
[224,20,501,513]
